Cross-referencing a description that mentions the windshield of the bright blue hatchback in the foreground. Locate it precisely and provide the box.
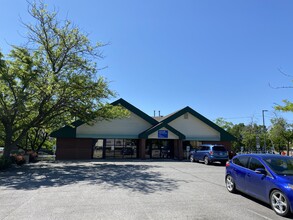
[264,157,293,175]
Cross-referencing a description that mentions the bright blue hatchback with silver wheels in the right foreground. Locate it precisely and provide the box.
[225,154,293,216]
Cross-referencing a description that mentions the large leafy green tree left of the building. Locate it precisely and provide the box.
[0,2,127,157]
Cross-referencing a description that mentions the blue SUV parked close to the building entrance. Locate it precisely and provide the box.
[189,144,229,165]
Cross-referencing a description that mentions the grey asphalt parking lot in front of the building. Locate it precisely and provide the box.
[0,160,284,220]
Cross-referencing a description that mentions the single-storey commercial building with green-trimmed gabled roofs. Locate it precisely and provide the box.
[51,99,235,160]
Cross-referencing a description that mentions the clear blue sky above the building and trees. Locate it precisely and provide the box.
[0,0,293,124]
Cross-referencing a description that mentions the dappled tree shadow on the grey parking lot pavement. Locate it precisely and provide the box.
[0,162,178,194]
